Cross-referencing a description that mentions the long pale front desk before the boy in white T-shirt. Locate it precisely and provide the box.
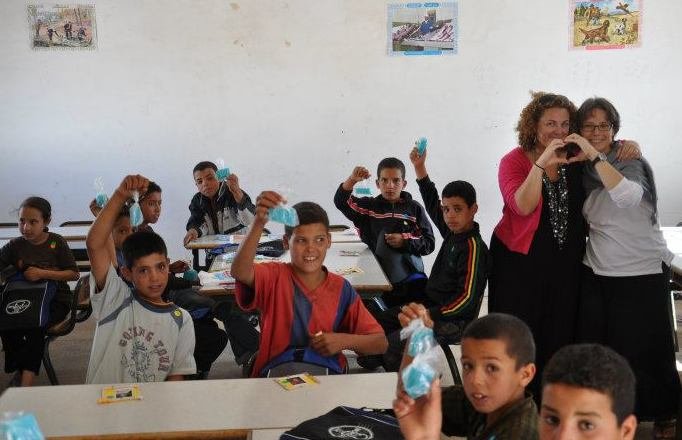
[0,373,397,440]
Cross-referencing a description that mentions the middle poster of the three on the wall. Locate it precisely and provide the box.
[388,2,458,55]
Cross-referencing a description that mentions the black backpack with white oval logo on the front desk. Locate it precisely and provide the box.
[280,406,404,440]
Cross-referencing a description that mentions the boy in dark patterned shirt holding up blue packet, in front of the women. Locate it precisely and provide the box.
[393,312,538,440]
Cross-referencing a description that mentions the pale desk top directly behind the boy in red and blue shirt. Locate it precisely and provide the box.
[199,243,393,296]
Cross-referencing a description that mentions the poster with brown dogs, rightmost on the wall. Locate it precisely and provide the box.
[569,0,642,50]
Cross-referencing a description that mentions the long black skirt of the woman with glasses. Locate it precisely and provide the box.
[578,265,680,420]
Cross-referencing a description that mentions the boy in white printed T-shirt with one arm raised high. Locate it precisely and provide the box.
[86,175,196,383]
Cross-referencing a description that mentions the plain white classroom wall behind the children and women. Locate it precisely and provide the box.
[0,0,682,264]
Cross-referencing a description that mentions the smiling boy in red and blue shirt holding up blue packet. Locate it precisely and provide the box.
[232,191,387,377]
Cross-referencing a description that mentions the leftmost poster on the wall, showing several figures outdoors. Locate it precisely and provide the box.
[28,5,97,49]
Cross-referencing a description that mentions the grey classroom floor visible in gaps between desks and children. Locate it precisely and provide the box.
[0,299,682,440]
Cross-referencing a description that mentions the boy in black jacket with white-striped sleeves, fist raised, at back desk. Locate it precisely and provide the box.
[334,157,435,314]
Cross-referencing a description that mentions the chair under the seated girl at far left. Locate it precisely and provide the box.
[43,275,92,385]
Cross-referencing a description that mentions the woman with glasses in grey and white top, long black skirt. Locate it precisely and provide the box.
[566,98,680,439]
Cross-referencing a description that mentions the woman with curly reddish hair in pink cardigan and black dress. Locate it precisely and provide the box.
[488,92,639,398]
